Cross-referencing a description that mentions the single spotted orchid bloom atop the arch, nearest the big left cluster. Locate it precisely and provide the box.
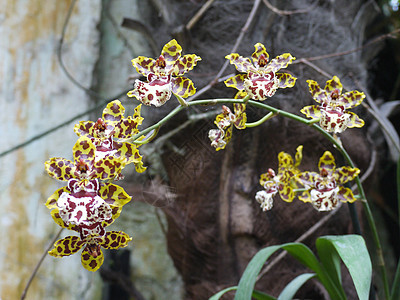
[128,40,201,106]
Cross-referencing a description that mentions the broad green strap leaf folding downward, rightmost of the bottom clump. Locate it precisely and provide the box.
[316,234,372,300]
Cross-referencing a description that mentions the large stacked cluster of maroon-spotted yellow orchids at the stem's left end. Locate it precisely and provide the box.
[45,100,145,271]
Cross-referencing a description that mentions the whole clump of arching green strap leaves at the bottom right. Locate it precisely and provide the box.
[210,235,372,300]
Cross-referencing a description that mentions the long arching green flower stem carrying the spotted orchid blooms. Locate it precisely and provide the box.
[132,98,390,299]
